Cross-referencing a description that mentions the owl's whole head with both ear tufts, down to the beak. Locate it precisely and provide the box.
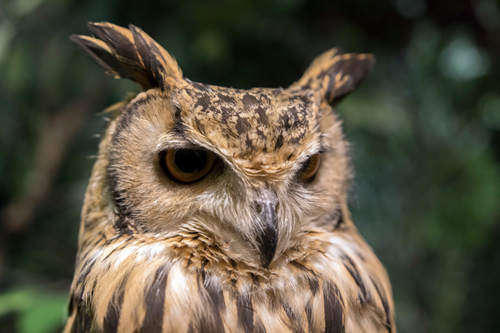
[72,23,374,267]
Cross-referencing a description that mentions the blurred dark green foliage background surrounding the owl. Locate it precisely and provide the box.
[0,0,500,333]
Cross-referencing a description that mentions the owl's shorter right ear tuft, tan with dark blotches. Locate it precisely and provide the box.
[290,49,375,105]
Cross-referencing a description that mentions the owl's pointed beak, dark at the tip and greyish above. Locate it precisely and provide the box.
[255,189,278,267]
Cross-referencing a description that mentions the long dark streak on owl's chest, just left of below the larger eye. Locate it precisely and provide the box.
[139,263,172,333]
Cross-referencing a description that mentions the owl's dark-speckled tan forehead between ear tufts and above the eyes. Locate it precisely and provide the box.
[175,82,319,164]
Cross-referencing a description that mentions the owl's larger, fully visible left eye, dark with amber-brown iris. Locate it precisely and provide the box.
[160,149,215,184]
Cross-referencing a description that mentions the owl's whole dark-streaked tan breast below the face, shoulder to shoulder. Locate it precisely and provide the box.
[74,232,389,332]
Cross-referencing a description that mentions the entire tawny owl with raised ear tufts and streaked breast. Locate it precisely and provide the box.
[64,23,396,333]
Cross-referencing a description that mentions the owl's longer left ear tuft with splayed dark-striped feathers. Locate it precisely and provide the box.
[70,22,182,89]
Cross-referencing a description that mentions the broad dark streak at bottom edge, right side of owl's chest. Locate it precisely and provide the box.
[323,282,345,333]
